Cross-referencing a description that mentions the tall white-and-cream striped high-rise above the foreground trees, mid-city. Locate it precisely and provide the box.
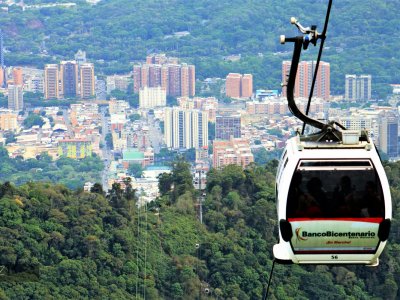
[164,107,208,149]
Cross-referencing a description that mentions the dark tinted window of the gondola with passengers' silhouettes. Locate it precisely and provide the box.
[286,162,385,219]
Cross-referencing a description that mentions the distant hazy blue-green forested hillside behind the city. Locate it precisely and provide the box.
[0,0,400,96]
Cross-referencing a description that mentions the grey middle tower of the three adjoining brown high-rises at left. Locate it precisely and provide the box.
[60,61,79,98]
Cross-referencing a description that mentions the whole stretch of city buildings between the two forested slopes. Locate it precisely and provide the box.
[0,42,399,206]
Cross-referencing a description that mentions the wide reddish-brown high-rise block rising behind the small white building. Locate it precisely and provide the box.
[133,57,196,97]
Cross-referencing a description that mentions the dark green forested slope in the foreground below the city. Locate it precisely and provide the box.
[0,161,400,300]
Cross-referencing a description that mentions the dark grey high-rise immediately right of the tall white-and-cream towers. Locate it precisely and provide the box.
[215,115,242,140]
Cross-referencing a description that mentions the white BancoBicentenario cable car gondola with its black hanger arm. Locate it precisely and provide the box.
[273,0,392,266]
